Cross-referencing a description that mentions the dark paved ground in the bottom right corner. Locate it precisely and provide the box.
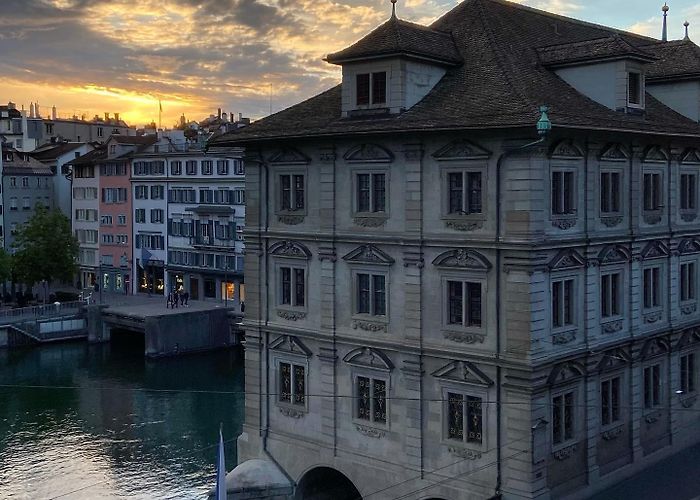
[589,444,700,500]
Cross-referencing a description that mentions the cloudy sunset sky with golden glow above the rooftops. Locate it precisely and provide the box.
[0,0,700,127]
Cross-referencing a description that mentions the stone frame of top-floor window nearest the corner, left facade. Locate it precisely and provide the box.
[440,163,489,224]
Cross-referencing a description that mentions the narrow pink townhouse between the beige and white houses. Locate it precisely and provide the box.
[99,135,156,293]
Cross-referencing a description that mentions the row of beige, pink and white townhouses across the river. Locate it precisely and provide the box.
[70,132,245,305]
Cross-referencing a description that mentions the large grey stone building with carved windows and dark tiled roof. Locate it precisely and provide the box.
[215,0,700,500]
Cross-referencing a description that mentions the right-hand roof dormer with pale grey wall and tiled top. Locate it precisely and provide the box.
[537,34,656,113]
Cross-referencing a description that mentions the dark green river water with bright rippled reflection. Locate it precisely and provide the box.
[0,334,244,500]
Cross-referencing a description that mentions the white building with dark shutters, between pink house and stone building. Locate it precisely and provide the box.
[132,132,245,306]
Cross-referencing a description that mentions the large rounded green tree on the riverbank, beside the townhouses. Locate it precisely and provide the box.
[12,205,78,284]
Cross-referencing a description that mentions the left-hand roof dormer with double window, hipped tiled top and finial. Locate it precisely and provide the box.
[326,6,462,117]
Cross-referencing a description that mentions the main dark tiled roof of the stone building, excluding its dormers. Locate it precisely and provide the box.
[212,0,700,145]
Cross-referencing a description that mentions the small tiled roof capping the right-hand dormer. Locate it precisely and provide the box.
[537,34,656,66]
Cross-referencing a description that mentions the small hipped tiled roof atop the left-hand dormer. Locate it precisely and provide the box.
[326,16,462,65]
